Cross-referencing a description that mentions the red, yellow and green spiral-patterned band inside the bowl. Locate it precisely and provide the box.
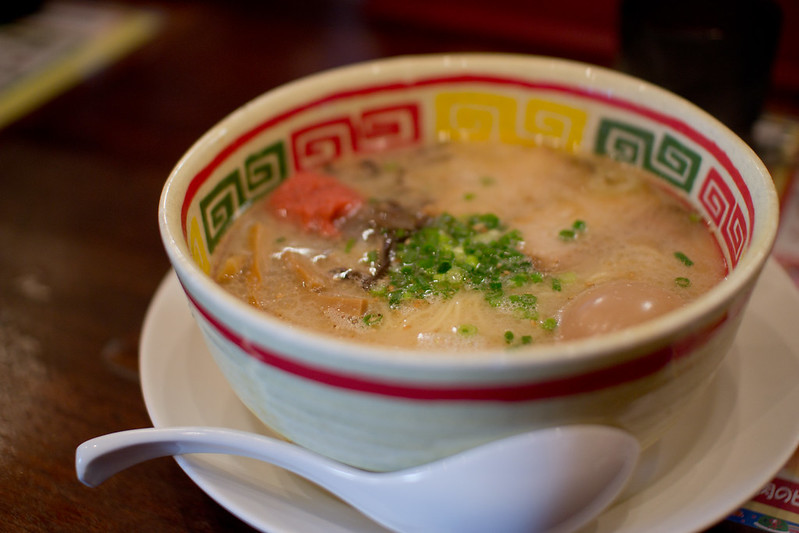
[183,77,752,270]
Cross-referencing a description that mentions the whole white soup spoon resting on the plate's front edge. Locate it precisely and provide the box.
[75,425,640,533]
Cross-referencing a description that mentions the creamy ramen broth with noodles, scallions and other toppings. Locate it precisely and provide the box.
[212,143,726,350]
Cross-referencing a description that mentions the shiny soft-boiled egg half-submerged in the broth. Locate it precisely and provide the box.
[558,280,683,340]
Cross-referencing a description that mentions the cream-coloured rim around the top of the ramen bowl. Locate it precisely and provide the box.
[158,53,779,371]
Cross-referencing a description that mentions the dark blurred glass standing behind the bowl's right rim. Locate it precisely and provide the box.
[618,0,782,142]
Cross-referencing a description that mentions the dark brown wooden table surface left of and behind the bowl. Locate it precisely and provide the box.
[0,1,796,532]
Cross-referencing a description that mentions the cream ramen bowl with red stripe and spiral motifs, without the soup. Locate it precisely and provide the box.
[159,54,778,471]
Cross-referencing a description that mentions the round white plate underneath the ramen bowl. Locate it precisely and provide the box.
[140,260,799,533]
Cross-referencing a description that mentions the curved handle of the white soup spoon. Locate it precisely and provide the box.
[75,426,354,487]
